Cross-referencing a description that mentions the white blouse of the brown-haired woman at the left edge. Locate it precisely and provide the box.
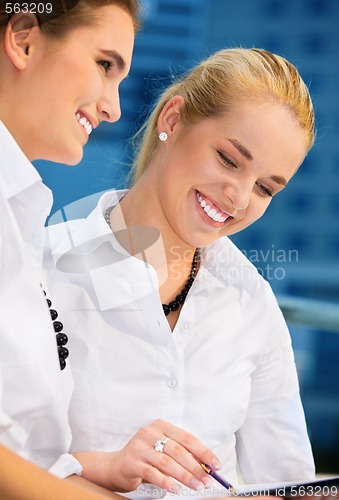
[0,122,81,480]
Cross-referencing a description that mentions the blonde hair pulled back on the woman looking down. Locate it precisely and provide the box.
[132,48,315,182]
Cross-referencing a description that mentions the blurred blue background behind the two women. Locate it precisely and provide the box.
[36,0,339,473]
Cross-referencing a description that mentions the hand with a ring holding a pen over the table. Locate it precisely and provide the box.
[74,420,221,493]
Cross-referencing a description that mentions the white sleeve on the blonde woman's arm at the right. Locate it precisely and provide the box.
[236,304,315,484]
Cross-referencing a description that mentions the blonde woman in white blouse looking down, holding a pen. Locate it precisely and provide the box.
[46,49,314,498]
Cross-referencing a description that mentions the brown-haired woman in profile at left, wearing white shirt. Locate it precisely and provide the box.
[0,0,139,500]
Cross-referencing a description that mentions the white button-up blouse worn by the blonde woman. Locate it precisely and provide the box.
[46,192,314,497]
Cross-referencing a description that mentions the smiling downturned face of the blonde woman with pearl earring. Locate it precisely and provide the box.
[139,96,307,251]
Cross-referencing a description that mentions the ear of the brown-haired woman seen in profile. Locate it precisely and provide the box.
[4,12,39,69]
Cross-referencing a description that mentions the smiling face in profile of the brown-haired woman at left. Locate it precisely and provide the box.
[0,2,134,164]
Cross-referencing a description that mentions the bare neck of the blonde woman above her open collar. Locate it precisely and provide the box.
[110,179,200,329]
